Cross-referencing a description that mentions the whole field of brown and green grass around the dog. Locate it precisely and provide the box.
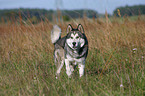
[0,16,145,96]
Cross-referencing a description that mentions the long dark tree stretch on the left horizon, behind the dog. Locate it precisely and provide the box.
[0,8,98,23]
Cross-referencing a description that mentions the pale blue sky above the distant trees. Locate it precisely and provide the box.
[0,0,145,14]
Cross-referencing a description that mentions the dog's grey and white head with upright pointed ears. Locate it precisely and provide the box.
[66,24,85,50]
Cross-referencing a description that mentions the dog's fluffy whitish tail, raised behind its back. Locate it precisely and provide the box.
[51,25,61,44]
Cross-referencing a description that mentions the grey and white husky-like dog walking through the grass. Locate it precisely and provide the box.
[51,24,88,78]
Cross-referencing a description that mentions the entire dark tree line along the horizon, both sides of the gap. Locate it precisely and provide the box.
[0,5,145,23]
